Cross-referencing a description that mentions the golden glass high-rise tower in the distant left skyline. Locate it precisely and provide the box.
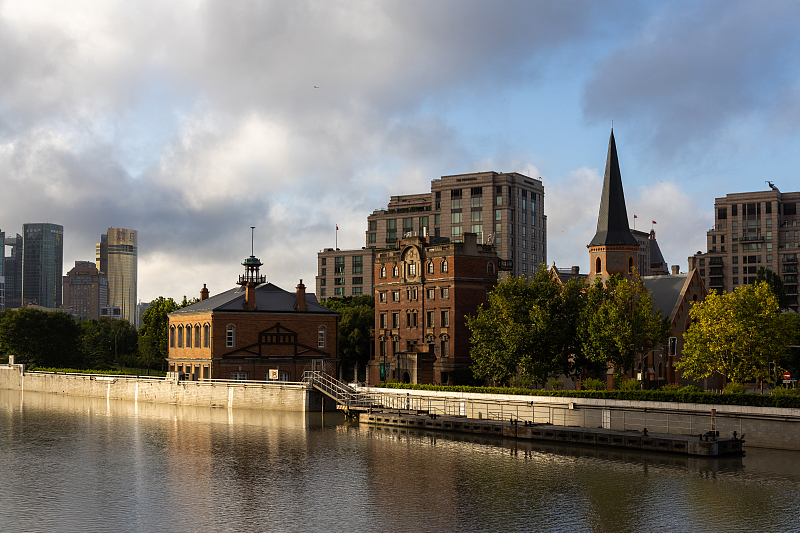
[96,228,139,324]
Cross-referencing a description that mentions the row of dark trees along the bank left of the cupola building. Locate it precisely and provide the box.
[0,296,197,373]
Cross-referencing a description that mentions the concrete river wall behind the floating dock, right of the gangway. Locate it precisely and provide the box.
[360,387,800,450]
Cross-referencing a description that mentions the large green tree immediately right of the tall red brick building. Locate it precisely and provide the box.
[467,266,584,384]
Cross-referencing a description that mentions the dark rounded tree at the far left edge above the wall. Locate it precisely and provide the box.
[0,307,85,368]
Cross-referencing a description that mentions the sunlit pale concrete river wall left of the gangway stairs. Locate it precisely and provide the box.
[0,365,336,412]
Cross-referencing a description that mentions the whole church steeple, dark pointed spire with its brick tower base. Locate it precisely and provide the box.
[587,129,639,279]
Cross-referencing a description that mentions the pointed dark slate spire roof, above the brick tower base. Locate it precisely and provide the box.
[589,131,639,246]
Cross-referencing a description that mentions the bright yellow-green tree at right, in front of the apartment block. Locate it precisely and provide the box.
[675,281,795,383]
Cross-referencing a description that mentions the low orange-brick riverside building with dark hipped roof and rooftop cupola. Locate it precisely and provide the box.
[167,252,339,381]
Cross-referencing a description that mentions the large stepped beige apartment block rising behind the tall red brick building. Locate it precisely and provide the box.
[366,172,547,276]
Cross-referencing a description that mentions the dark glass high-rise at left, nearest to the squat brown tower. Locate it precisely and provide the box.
[22,223,64,308]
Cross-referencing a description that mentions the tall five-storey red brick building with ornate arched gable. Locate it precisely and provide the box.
[368,233,501,384]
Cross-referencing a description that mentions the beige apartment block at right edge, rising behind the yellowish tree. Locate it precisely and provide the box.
[689,188,800,311]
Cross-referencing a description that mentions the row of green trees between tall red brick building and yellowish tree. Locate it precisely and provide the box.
[467,268,669,384]
